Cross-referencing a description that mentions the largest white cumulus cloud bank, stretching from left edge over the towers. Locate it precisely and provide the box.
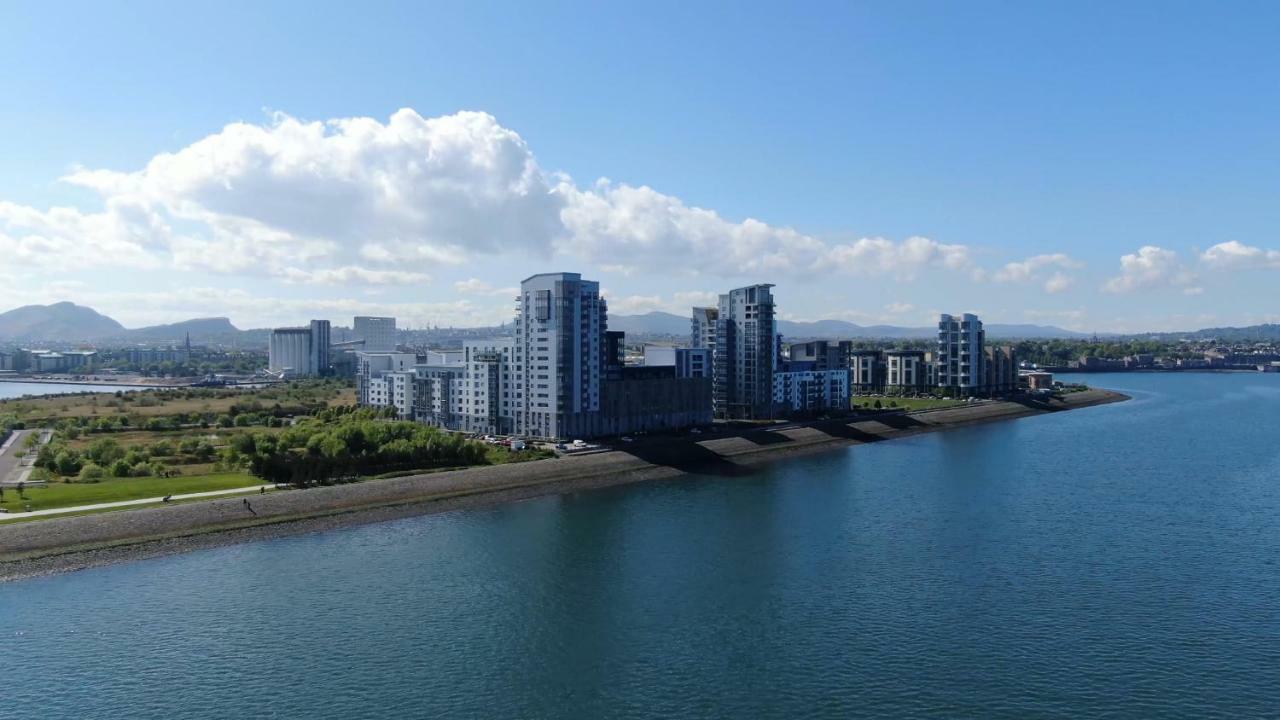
[0,109,977,284]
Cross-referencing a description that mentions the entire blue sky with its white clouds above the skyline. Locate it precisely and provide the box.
[0,0,1280,332]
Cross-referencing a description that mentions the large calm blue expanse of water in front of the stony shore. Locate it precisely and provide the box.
[0,374,1280,719]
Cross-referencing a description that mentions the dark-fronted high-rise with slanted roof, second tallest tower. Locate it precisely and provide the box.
[712,284,778,419]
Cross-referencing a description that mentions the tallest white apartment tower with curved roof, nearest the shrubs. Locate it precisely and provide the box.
[511,273,607,438]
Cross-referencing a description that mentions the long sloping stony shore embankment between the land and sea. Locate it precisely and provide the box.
[0,389,1129,582]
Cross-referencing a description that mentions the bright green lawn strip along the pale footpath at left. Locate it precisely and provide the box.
[0,473,261,512]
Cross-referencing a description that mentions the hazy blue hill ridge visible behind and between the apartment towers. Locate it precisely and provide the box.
[609,311,1088,340]
